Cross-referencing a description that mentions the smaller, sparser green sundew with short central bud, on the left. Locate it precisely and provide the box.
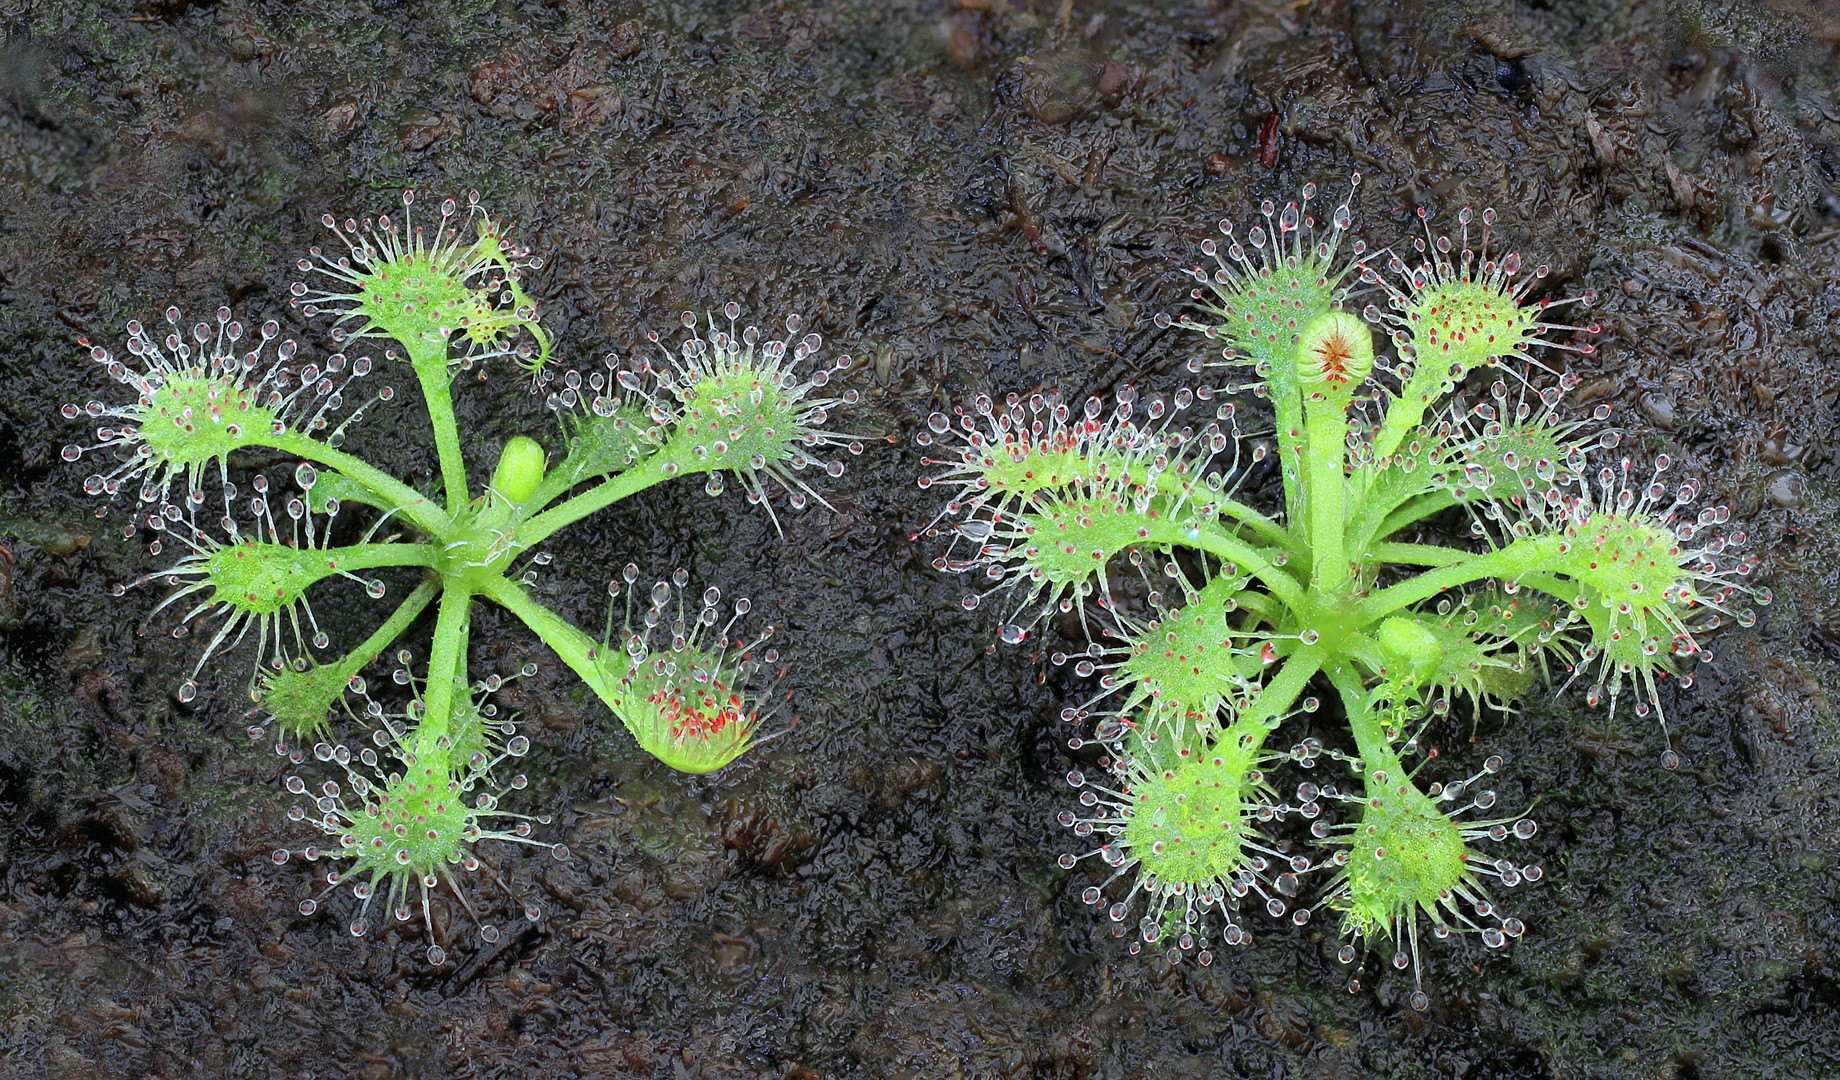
[64,191,863,964]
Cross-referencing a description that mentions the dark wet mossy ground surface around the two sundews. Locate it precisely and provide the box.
[0,0,1840,1078]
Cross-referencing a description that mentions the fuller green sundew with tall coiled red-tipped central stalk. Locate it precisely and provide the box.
[920,177,1770,1008]
